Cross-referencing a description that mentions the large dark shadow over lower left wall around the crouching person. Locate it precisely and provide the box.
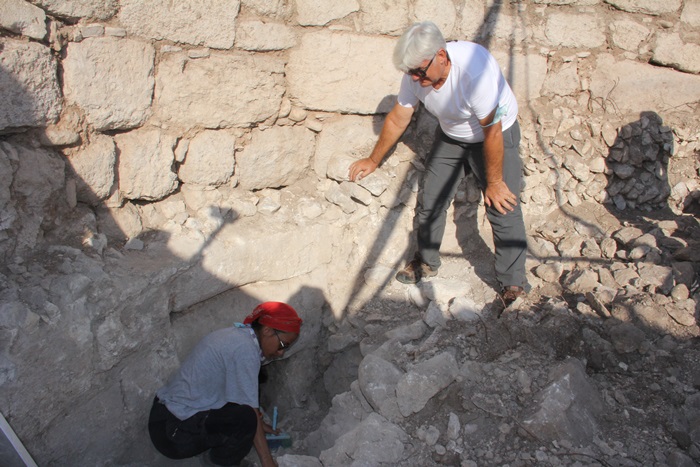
[0,62,325,465]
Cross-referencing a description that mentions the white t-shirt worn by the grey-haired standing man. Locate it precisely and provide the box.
[398,41,518,143]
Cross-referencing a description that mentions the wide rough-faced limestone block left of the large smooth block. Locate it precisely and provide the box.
[155,52,284,128]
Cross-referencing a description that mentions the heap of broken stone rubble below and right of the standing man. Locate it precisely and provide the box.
[278,205,700,467]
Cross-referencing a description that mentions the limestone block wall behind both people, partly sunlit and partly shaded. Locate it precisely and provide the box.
[0,0,700,465]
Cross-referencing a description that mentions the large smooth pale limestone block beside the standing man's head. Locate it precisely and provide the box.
[286,31,401,114]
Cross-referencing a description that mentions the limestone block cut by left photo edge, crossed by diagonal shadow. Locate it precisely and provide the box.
[0,38,62,130]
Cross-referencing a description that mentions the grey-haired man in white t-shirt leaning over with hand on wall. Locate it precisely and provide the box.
[350,21,527,305]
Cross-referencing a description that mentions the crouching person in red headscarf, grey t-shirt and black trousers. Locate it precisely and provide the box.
[148,302,301,467]
